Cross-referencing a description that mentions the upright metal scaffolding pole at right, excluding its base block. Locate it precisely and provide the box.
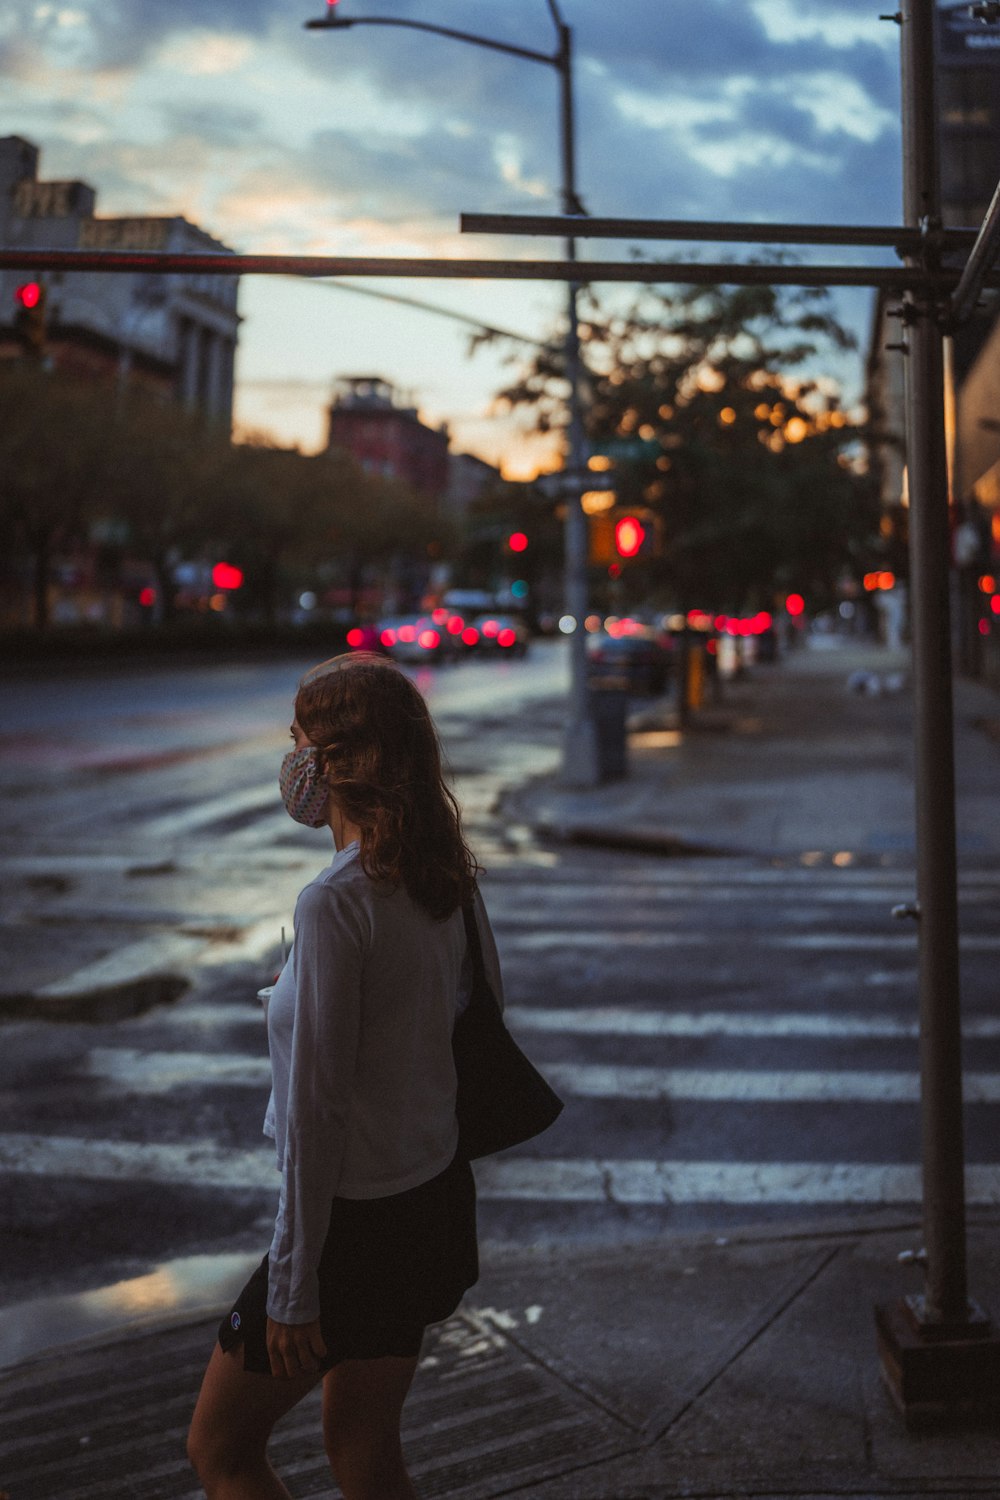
[901,0,967,1323]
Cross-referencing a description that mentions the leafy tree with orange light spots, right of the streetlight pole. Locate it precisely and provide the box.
[499,276,877,612]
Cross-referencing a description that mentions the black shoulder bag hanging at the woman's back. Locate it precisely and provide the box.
[451,906,562,1161]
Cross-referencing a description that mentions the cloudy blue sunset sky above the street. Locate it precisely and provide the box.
[0,0,900,473]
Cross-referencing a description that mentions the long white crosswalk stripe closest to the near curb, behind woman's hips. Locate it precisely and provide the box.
[0,1134,1000,1208]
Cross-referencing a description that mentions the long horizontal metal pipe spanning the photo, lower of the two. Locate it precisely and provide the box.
[0,249,1000,294]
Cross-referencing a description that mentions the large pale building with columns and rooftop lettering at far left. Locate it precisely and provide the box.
[0,135,240,428]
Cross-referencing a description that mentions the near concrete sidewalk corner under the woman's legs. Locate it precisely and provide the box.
[0,1226,1000,1500]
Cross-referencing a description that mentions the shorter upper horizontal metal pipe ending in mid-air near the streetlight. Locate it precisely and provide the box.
[460,213,976,254]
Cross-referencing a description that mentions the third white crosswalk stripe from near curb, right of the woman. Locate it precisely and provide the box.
[509,1005,1000,1041]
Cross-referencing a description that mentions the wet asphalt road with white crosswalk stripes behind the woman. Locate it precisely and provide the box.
[0,647,1000,1350]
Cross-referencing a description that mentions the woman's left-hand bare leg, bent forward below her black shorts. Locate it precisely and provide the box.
[187,1344,322,1500]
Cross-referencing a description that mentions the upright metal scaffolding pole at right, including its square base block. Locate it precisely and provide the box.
[876,0,1000,1421]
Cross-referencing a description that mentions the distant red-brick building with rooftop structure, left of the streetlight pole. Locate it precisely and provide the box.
[327,375,448,507]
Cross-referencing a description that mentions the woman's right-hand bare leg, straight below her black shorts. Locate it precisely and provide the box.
[322,1356,417,1500]
